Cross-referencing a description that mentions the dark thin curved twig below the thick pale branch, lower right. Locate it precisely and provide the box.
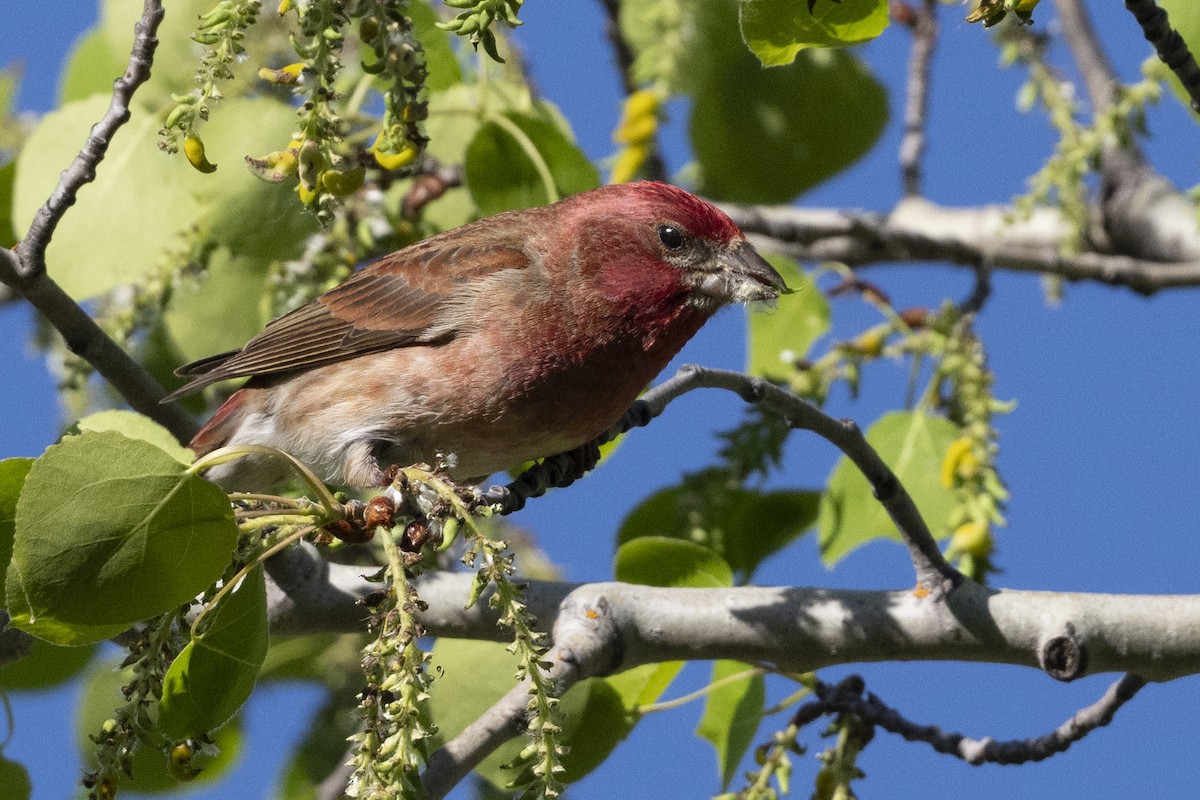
[792,673,1146,764]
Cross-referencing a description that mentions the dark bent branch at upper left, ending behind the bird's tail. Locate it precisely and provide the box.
[0,0,196,443]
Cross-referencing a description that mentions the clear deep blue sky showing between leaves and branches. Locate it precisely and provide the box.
[0,0,1200,800]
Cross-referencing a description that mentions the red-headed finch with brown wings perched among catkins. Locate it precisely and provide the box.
[164,181,788,492]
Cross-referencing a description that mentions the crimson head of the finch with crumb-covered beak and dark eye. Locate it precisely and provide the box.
[565,181,788,313]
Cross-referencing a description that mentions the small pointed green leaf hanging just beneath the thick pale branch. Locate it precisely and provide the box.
[696,661,767,790]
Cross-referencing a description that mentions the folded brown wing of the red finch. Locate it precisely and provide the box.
[168,223,529,399]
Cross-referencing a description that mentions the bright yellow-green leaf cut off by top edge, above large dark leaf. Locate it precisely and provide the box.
[738,0,888,67]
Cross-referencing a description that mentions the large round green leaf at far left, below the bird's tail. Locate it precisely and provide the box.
[6,431,238,644]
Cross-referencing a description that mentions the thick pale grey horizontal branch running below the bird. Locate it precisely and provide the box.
[269,554,1200,681]
